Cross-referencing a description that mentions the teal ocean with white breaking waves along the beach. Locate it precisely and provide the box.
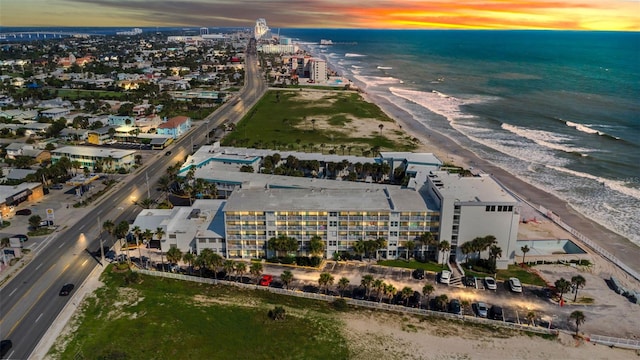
[280,29,640,245]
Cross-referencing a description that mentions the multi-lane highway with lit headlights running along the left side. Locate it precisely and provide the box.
[0,41,267,359]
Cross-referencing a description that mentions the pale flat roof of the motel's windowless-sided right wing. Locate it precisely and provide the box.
[428,171,518,203]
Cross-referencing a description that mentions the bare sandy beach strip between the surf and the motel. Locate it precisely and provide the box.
[360,88,640,283]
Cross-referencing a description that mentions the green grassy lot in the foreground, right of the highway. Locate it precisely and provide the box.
[50,268,349,359]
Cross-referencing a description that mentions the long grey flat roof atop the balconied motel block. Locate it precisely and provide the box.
[224,189,435,212]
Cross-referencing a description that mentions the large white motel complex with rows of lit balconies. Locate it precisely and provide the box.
[134,145,520,269]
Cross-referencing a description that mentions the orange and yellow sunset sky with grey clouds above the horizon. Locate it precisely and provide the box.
[0,0,640,31]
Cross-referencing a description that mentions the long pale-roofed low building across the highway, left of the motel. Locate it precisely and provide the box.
[51,146,136,171]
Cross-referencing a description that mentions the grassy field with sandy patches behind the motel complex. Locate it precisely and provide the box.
[222,90,416,155]
